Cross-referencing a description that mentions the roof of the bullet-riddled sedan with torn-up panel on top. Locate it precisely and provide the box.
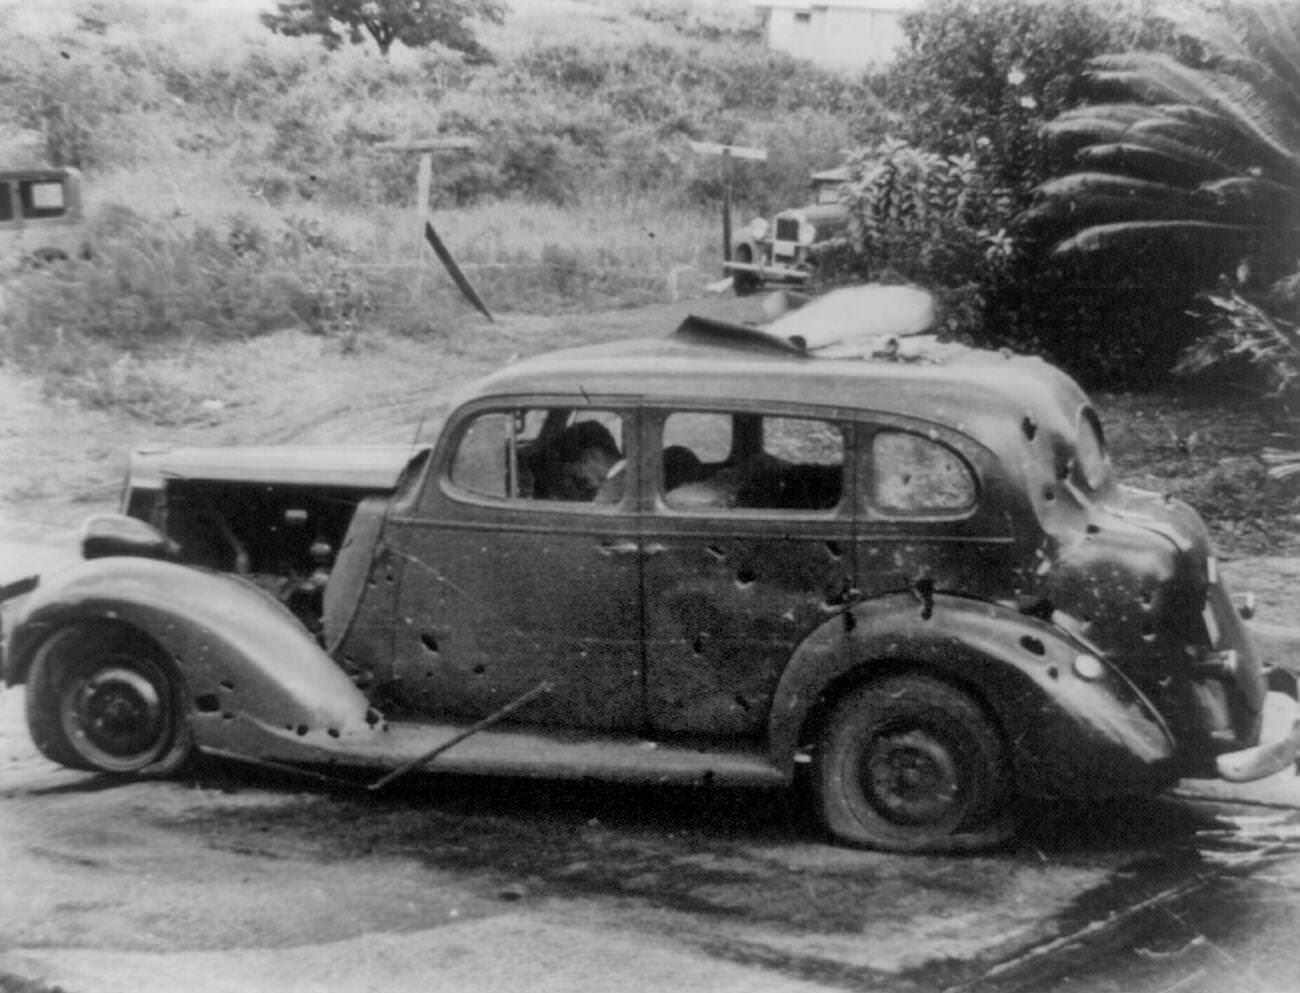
[473,287,1087,437]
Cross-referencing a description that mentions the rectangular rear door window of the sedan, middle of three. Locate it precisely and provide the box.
[660,412,844,512]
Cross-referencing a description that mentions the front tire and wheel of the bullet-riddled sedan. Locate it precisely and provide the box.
[26,624,194,779]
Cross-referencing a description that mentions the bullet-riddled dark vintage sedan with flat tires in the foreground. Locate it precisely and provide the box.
[4,287,1300,851]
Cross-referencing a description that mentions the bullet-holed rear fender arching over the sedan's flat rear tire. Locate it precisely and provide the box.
[768,593,1177,797]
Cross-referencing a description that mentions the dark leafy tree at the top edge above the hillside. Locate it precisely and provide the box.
[261,0,506,57]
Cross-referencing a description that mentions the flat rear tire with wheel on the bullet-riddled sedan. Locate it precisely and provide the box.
[814,675,1014,851]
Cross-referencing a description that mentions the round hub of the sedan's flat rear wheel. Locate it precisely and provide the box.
[863,730,961,824]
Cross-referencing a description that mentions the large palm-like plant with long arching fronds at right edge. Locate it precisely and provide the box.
[1019,0,1300,390]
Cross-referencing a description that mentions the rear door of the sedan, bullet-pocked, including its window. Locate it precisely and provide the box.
[642,407,854,738]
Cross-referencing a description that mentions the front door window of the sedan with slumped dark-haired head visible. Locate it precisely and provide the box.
[451,407,627,503]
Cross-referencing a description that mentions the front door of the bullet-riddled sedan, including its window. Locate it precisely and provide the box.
[387,400,644,729]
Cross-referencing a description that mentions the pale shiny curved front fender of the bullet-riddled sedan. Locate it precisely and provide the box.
[8,556,377,759]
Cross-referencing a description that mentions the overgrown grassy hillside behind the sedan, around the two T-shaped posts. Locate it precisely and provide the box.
[0,0,872,402]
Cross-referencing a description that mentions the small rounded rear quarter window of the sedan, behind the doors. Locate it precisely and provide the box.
[871,430,975,513]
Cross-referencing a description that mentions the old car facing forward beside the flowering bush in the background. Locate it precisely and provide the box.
[723,166,849,296]
